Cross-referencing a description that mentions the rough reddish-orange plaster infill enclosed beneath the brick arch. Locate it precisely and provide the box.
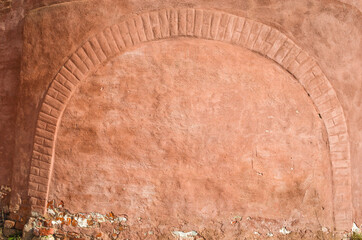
[49,40,333,232]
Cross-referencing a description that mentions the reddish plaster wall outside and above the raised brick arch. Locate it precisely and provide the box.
[0,0,362,232]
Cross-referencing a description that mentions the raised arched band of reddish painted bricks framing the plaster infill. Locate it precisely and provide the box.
[29,9,352,230]
